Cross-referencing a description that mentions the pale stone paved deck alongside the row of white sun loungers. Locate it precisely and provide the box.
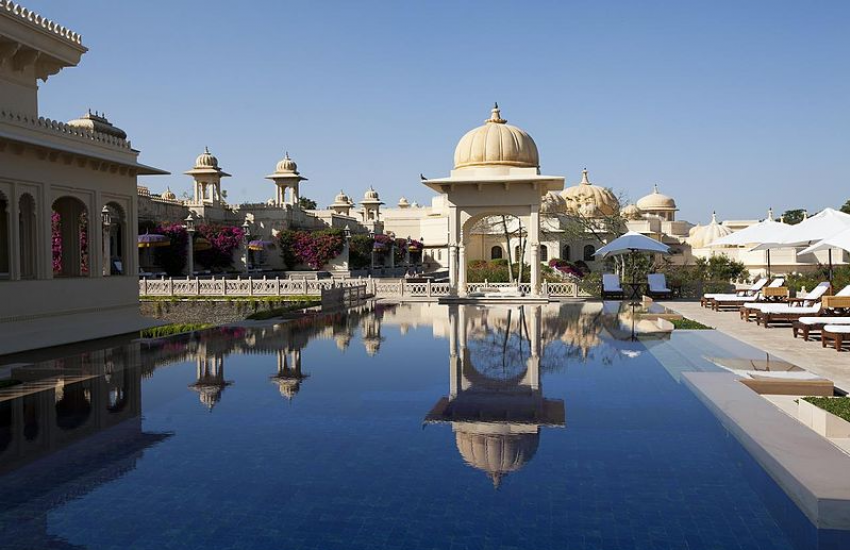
[663,302,850,392]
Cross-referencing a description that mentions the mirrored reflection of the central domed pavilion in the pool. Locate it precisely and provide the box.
[425,305,566,487]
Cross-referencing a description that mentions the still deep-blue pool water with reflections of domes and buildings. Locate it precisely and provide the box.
[0,304,846,550]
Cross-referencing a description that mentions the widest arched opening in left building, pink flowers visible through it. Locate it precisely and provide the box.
[51,197,89,277]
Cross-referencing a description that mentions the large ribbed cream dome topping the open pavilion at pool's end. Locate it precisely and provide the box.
[454,104,540,169]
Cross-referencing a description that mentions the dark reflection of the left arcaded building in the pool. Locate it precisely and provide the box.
[0,344,171,548]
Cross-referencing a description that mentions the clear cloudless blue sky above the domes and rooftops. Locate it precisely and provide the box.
[23,0,850,221]
